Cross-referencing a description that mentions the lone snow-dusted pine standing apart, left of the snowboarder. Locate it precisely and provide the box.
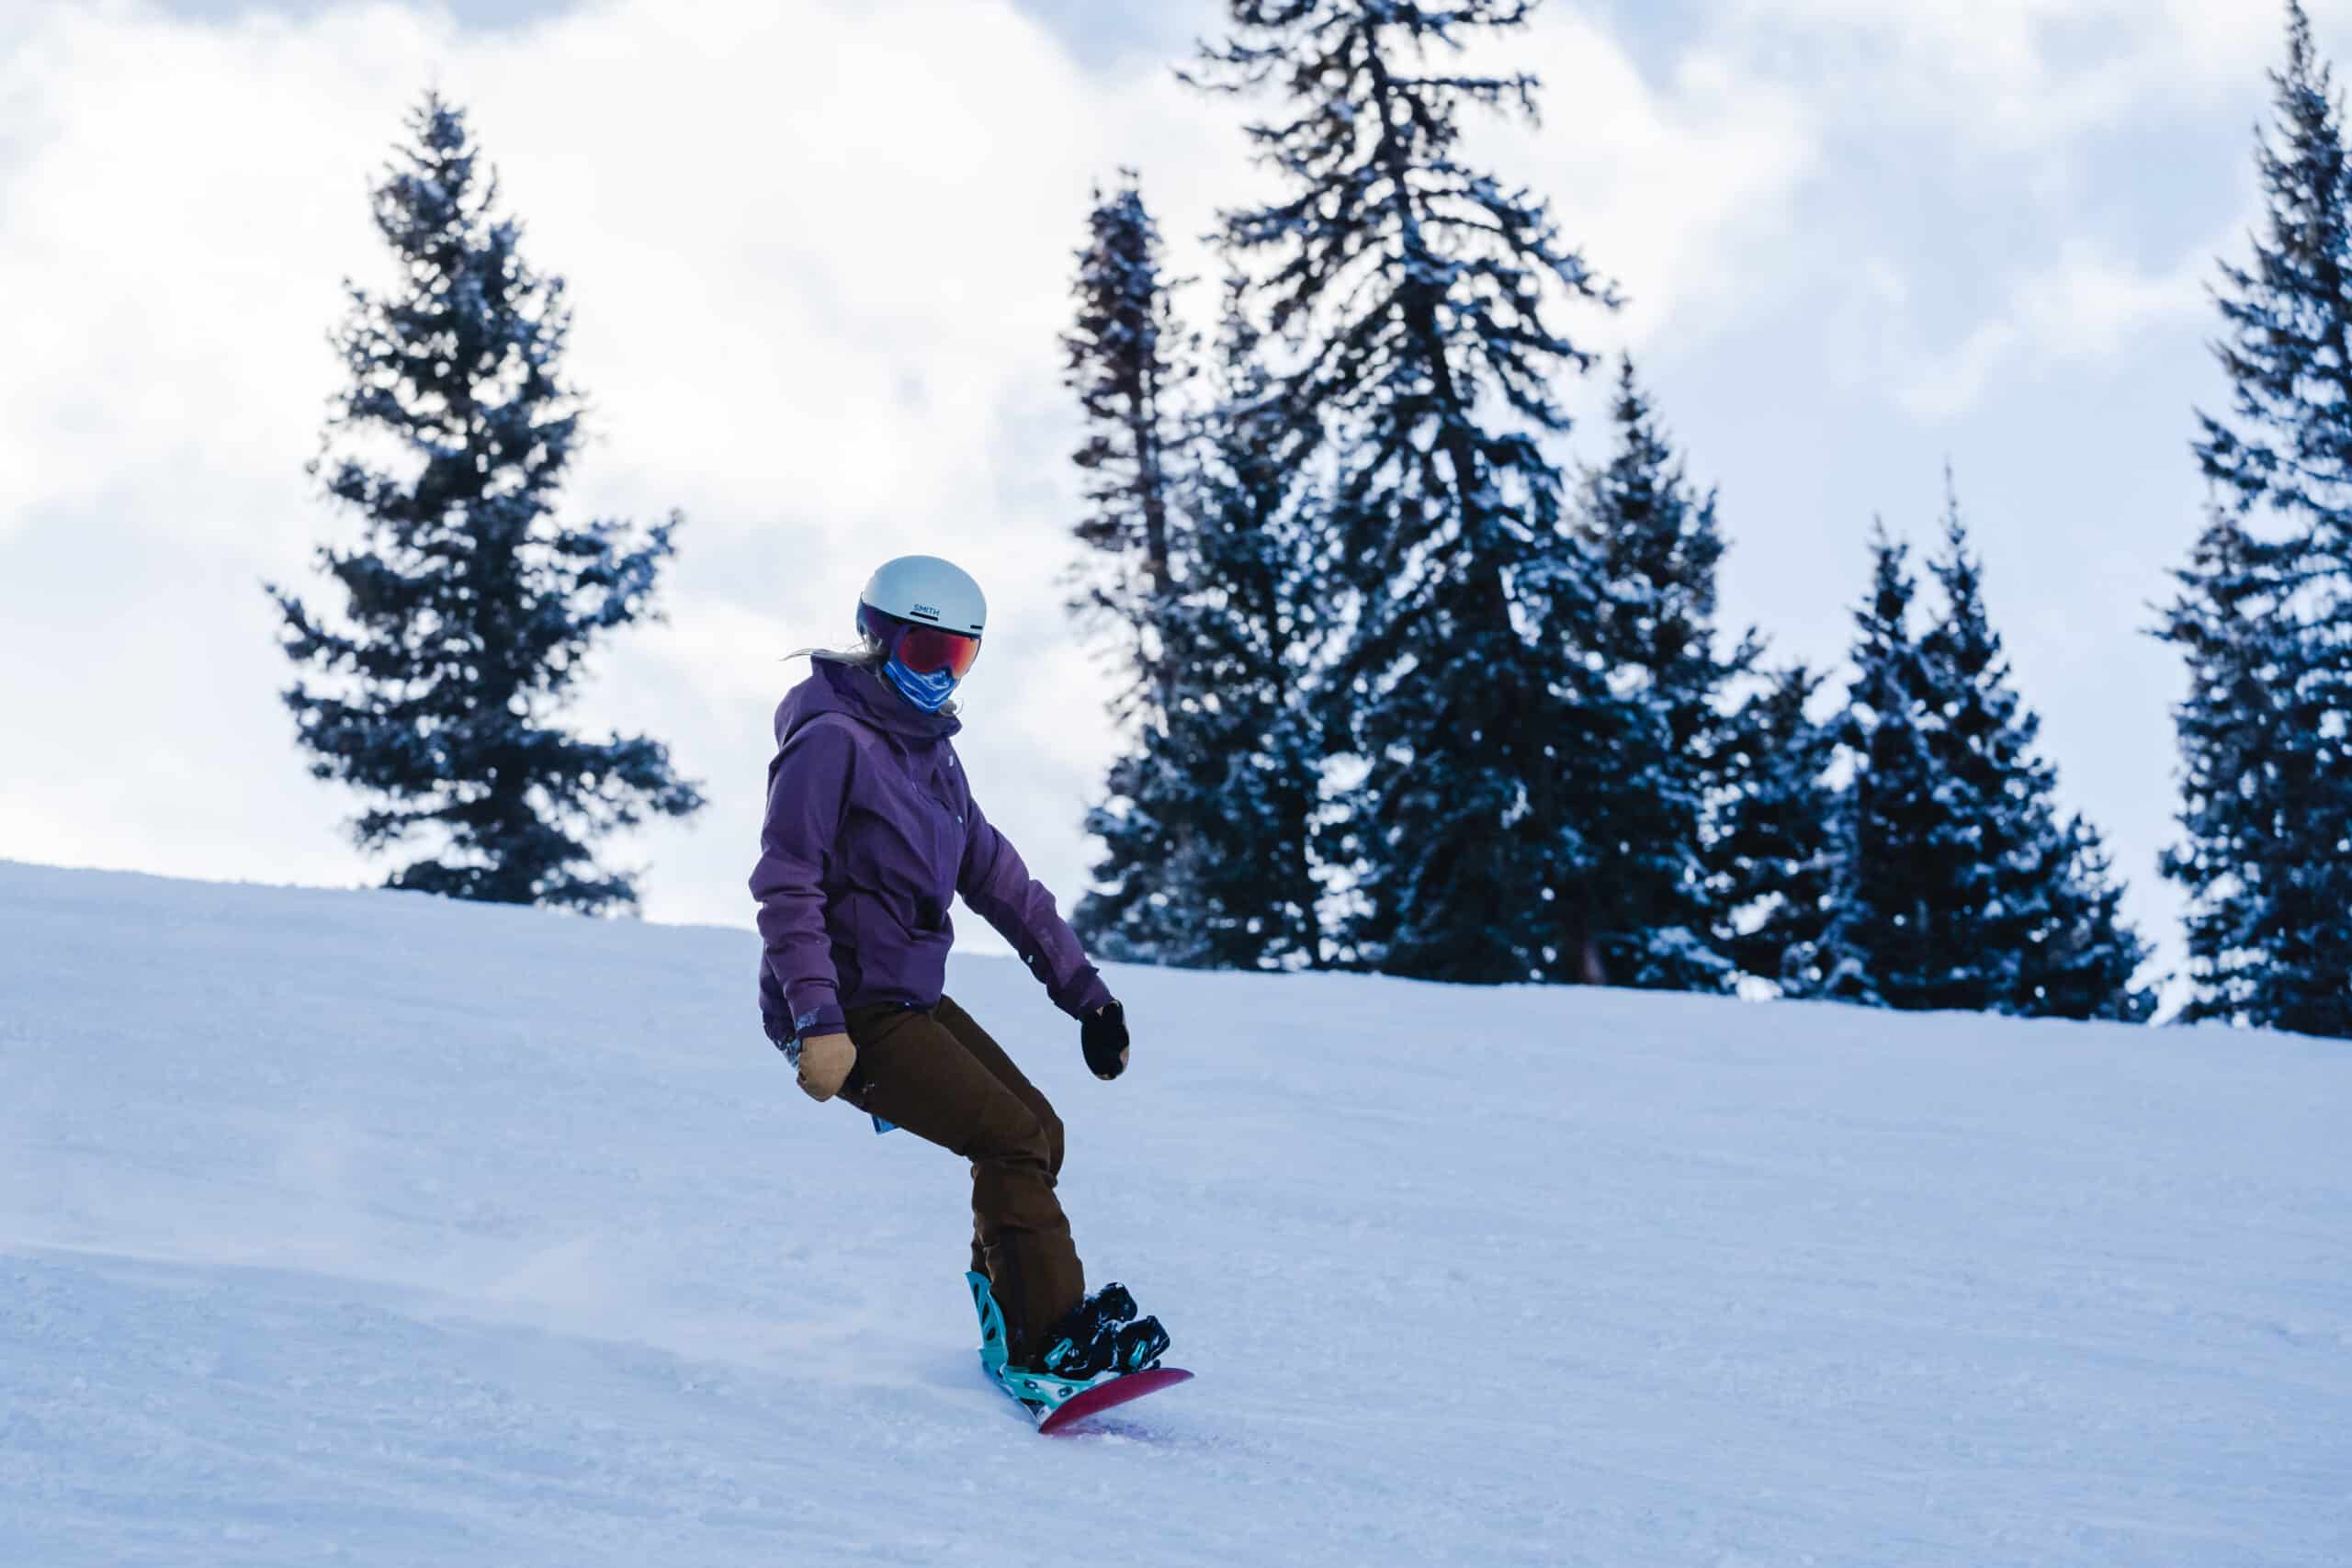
[270,94,703,909]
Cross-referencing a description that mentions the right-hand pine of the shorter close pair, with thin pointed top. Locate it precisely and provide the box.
[1922,484,2154,1021]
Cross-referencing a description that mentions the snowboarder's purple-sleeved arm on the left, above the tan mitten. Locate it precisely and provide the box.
[751,719,856,1039]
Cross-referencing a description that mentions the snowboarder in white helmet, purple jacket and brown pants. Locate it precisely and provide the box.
[751,555,1169,1380]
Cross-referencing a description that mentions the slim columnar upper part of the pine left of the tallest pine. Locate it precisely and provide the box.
[1063,169,1188,712]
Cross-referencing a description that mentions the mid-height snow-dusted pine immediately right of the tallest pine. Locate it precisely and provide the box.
[1564,357,1755,989]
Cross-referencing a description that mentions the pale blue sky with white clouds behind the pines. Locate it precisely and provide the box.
[0,0,2324,987]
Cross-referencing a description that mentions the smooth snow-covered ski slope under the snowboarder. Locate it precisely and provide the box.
[0,865,2352,1568]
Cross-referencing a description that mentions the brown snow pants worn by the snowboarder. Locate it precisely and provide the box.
[842,997,1087,1366]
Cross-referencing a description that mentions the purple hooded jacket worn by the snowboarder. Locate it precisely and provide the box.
[751,659,1110,1039]
